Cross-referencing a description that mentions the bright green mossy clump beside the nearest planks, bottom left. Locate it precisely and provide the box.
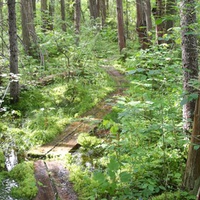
[10,162,38,199]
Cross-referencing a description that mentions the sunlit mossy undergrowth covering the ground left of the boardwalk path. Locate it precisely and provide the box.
[0,25,116,199]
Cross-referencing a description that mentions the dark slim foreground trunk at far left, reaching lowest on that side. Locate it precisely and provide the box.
[7,0,19,103]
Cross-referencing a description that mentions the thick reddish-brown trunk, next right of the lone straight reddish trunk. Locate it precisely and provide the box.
[136,0,149,49]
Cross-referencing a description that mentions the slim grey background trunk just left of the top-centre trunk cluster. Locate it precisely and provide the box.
[74,0,81,45]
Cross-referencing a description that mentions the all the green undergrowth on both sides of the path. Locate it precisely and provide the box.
[0,2,199,200]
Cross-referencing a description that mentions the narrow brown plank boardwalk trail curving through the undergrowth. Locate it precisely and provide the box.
[31,63,127,200]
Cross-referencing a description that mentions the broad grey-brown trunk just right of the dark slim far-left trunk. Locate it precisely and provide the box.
[21,0,37,56]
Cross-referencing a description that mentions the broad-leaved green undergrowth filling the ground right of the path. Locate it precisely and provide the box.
[65,45,195,200]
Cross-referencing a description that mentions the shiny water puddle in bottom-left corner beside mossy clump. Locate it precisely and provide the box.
[0,179,22,200]
